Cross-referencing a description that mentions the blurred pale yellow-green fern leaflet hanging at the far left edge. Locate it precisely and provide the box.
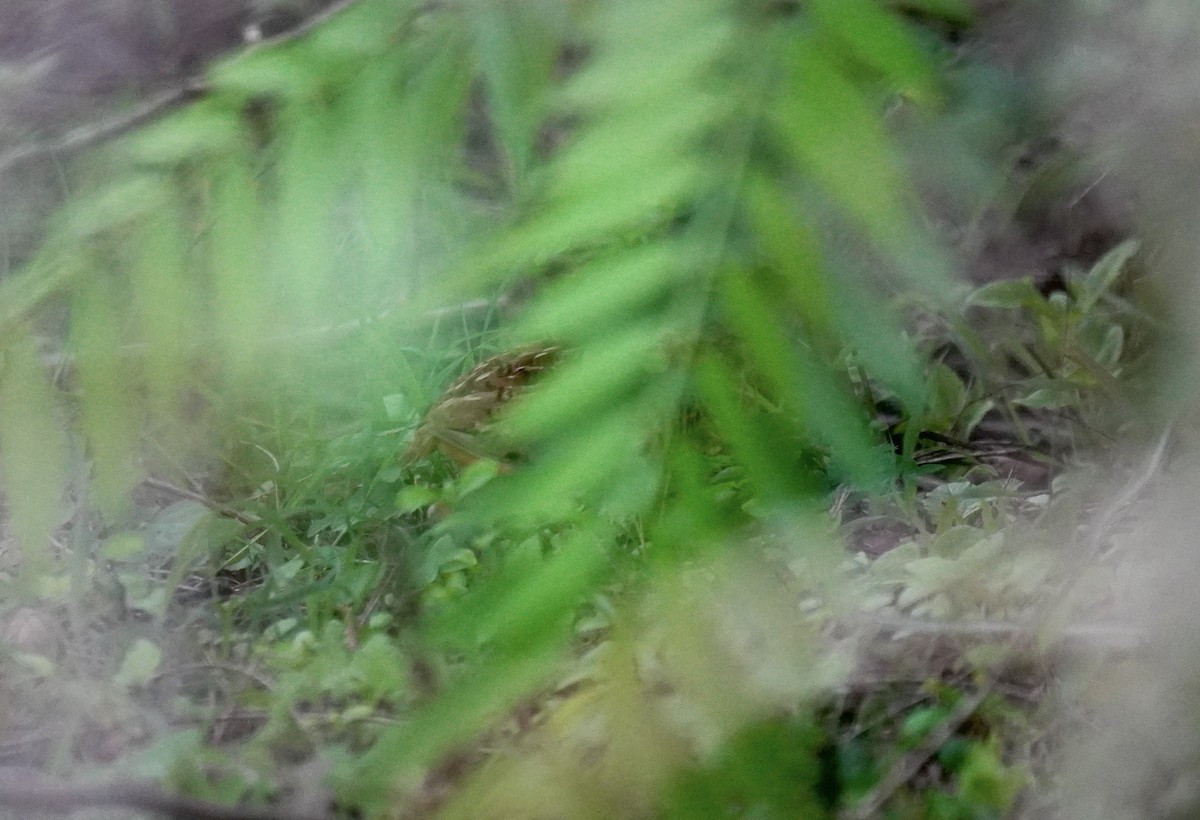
[0,335,67,577]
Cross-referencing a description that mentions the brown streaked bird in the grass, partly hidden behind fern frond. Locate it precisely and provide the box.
[401,345,560,467]
